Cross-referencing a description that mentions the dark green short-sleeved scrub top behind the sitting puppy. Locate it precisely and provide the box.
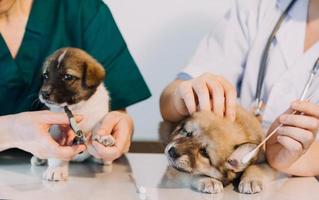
[0,0,151,115]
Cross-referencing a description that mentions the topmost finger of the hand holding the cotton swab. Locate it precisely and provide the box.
[291,101,319,119]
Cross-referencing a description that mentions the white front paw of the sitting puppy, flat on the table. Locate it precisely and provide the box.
[43,166,69,181]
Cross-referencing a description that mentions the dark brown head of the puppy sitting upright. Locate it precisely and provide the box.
[40,48,105,105]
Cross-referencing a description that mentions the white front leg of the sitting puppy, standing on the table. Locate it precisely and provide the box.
[43,158,69,181]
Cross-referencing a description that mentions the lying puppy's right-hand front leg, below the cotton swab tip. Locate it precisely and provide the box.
[238,163,276,194]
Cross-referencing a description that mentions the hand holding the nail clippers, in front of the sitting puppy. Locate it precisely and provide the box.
[9,111,86,160]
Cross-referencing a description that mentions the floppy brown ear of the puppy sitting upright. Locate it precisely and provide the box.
[82,62,105,87]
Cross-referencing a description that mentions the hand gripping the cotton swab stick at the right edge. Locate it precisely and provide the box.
[266,101,319,168]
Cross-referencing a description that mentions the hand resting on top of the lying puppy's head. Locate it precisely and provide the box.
[161,73,237,121]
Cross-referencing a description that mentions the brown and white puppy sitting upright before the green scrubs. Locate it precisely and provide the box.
[31,48,114,181]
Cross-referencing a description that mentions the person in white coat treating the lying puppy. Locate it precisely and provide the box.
[161,0,319,176]
